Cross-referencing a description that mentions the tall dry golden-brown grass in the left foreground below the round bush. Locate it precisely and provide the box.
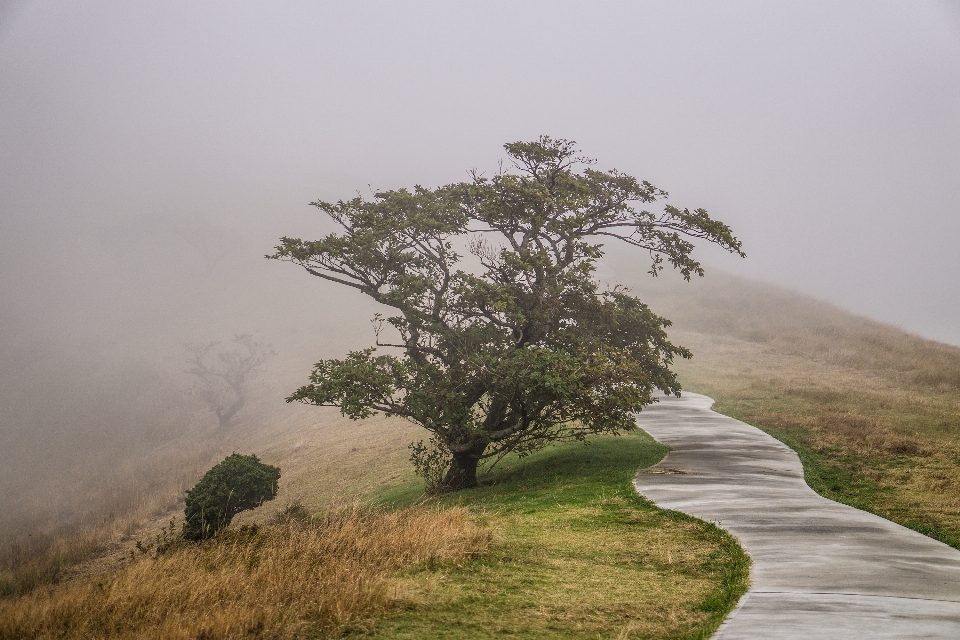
[0,505,490,639]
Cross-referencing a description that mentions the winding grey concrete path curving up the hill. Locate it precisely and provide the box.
[634,393,960,640]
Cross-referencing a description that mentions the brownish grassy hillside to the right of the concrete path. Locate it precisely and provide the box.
[636,274,960,548]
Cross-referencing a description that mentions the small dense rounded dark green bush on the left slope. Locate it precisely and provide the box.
[183,453,280,540]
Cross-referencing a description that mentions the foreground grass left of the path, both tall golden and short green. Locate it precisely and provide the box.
[0,433,748,639]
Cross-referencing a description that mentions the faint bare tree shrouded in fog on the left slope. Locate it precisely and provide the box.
[184,333,276,428]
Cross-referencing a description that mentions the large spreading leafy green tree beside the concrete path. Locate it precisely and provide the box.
[267,136,744,490]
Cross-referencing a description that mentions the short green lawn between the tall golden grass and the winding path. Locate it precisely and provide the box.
[357,433,749,639]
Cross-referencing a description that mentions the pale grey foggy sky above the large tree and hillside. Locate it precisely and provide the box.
[0,0,960,344]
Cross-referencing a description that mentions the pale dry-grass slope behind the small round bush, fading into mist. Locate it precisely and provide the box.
[0,403,415,597]
